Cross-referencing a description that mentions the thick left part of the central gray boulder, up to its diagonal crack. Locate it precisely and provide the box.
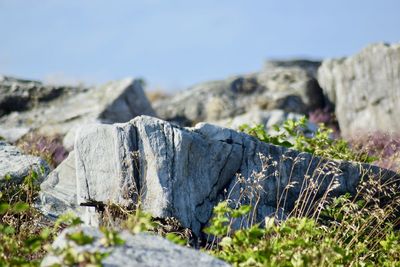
[75,116,242,233]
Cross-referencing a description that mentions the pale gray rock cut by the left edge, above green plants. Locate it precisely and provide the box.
[0,141,49,183]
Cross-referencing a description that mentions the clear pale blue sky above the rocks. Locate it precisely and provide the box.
[0,0,400,90]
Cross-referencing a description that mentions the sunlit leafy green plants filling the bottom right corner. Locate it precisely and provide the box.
[206,196,400,266]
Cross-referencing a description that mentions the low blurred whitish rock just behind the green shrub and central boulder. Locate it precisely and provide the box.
[212,109,317,132]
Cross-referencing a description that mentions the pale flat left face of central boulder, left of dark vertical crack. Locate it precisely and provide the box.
[75,124,137,208]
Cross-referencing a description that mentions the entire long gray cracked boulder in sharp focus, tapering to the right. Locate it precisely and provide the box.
[38,116,396,234]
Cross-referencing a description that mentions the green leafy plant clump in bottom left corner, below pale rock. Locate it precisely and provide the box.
[0,172,52,266]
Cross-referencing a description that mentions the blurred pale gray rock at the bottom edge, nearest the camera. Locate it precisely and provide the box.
[41,227,230,267]
